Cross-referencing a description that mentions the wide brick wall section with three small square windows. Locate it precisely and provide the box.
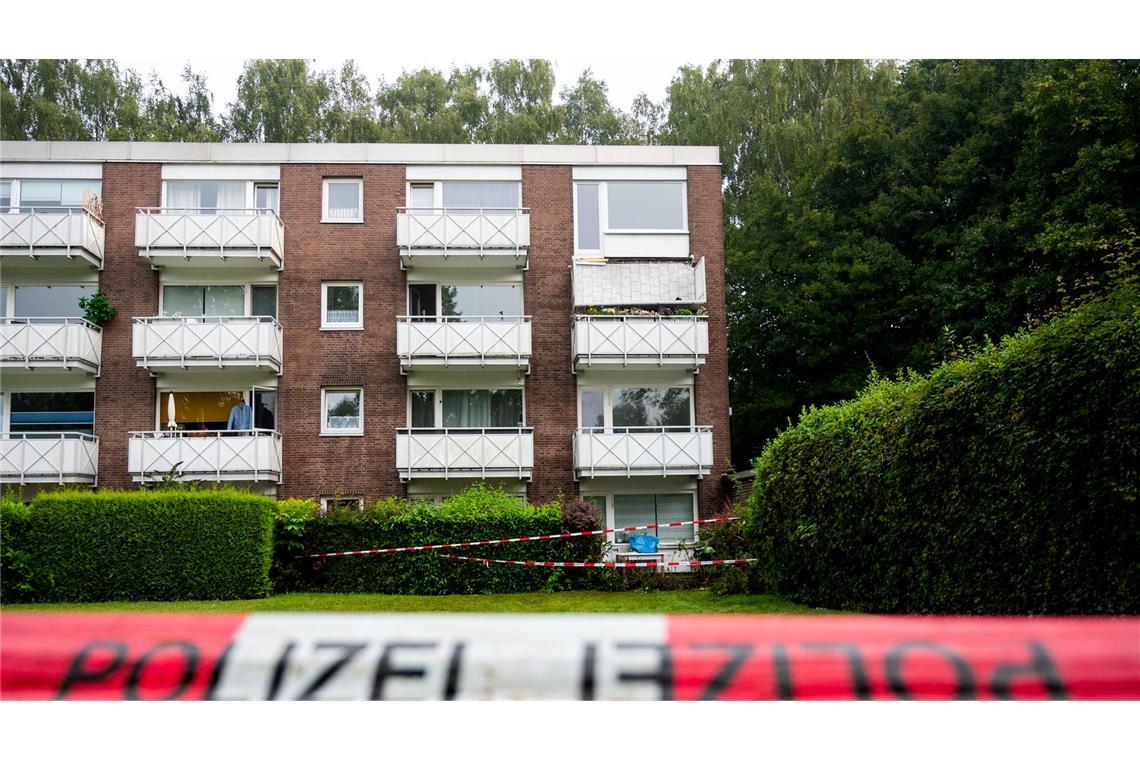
[277,164,407,498]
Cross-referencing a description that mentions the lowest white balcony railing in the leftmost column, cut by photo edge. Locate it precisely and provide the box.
[0,433,99,485]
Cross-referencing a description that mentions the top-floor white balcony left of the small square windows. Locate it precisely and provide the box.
[135,209,285,269]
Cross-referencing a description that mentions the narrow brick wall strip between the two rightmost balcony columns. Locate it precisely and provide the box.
[522,166,578,504]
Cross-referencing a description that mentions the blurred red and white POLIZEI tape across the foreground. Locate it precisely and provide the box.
[0,612,1140,700]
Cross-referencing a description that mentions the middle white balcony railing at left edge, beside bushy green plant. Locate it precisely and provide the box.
[0,317,103,375]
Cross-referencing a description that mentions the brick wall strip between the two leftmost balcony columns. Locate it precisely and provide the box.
[95,163,162,488]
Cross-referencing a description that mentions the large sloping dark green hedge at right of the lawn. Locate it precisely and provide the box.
[747,286,1140,614]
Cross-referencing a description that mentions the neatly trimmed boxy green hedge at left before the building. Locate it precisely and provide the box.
[22,489,274,602]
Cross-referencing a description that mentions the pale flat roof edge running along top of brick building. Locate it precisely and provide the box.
[0,140,720,166]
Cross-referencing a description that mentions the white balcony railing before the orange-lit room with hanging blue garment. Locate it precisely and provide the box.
[127,430,282,483]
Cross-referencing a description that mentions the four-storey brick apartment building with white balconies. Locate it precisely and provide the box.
[0,142,730,558]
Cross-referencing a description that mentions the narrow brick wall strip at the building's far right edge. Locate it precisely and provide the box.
[689,166,732,517]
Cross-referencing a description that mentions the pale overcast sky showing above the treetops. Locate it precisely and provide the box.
[117,56,693,113]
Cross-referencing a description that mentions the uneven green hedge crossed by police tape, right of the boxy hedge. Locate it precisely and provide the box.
[274,484,601,595]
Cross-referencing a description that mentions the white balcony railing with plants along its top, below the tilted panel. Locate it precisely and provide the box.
[572,316,709,369]
